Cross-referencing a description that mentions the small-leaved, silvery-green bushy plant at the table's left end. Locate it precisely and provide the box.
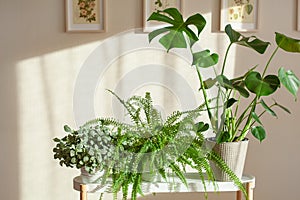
[53,121,113,174]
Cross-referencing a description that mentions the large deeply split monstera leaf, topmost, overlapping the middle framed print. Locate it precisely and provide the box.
[148,8,206,51]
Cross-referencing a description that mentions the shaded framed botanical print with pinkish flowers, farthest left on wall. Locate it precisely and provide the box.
[65,0,105,32]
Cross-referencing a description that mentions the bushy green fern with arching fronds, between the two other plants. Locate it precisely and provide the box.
[86,91,213,199]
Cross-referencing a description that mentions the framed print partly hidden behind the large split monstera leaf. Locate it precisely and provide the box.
[143,0,182,32]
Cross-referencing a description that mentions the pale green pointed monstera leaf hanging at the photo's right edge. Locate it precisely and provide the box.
[278,67,300,100]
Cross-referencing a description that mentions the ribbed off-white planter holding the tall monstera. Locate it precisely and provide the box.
[206,138,249,181]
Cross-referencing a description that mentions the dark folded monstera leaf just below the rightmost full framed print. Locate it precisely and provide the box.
[225,24,270,54]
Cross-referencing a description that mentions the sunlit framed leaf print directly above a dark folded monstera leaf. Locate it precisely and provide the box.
[220,0,258,31]
